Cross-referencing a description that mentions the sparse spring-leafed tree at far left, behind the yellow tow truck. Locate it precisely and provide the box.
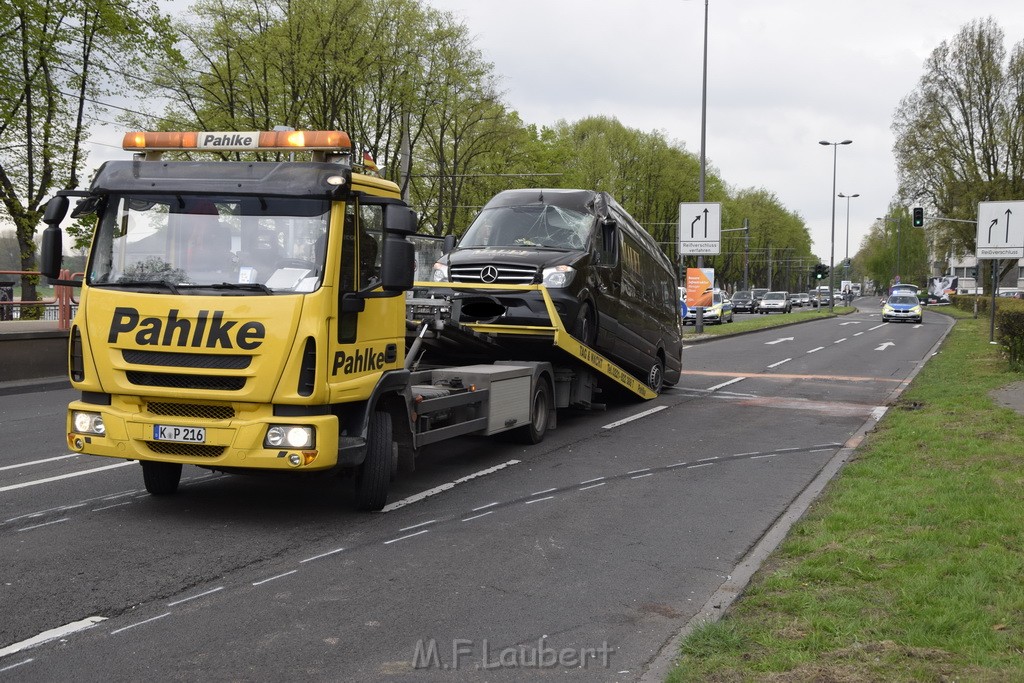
[0,0,167,317]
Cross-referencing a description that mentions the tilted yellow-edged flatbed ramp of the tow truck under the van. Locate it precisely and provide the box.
[407,283,657,399]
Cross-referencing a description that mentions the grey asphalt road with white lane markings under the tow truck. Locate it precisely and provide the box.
[0,298,950,681]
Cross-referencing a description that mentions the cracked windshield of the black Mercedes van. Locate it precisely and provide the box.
[459,204,597,250]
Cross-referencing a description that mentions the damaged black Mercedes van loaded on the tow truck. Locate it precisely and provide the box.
[431,189,682,391]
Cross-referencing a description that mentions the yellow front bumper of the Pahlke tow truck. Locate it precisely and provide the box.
[67,395,339,471]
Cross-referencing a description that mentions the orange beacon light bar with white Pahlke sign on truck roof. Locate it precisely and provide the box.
[122,130,352,154]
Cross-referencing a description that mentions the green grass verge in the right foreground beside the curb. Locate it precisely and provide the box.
[668,308,1024,682]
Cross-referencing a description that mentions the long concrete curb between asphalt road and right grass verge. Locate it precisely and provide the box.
[639,311,956,683]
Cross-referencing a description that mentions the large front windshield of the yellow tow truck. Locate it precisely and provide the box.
[87,195,330,296]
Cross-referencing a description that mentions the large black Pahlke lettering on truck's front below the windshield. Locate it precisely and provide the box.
[106,306,266,351]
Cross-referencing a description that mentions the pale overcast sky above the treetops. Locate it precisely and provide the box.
[425,0,1024,263]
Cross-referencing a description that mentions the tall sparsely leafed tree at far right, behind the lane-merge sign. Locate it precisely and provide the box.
[893,17,1024,264]
